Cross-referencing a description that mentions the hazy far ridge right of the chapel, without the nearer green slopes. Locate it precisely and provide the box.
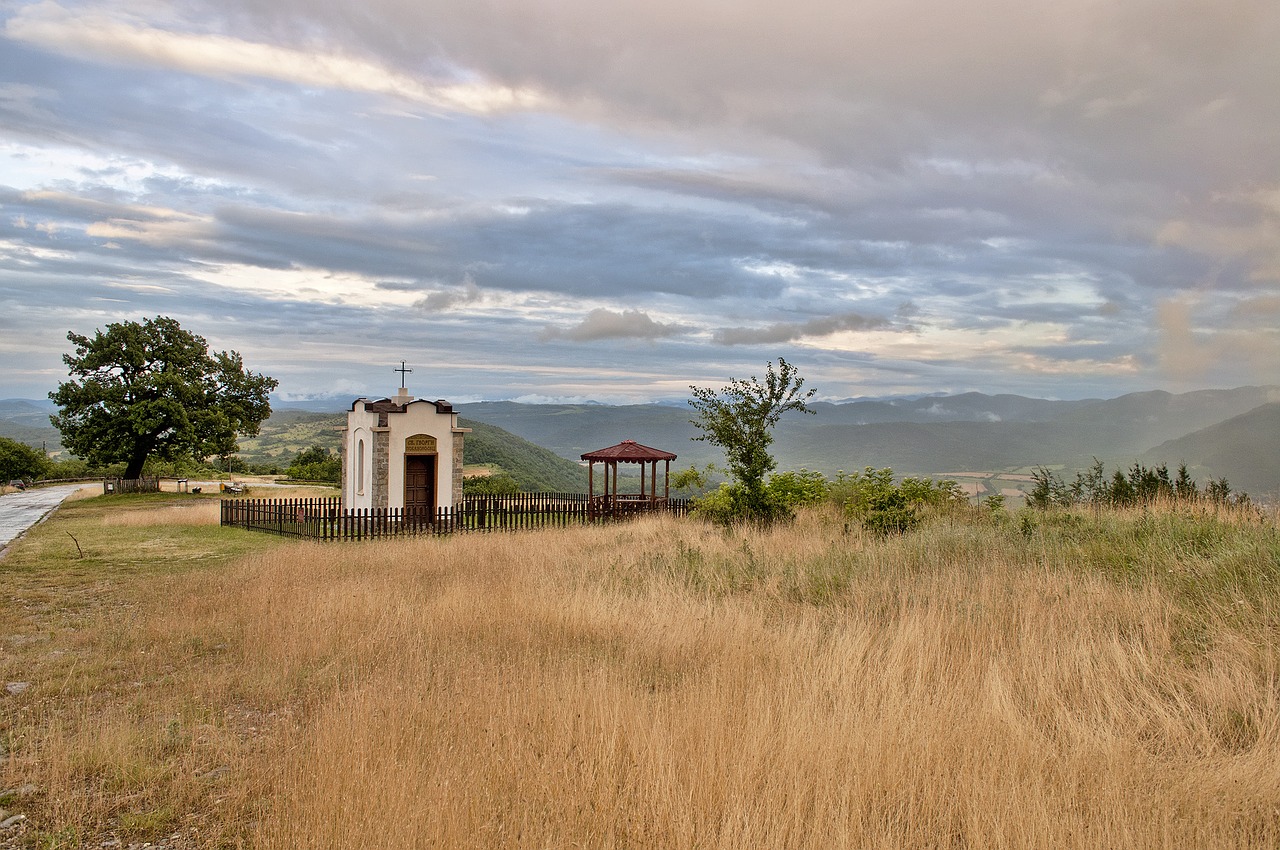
[460,387,1280,484]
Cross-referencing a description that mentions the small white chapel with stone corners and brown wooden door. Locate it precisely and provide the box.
[339,386,471,521]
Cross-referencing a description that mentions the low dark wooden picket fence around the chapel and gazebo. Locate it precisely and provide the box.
[221,493,689,540]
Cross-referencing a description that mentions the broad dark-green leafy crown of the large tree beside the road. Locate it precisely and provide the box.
[49,316,278,477]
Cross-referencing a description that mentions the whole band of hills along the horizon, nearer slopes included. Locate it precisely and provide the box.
[0,387,1280,498]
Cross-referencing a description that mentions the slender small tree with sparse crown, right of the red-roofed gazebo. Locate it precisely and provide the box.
[689,357,817,522]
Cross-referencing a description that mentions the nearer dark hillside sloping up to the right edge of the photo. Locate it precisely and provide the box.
[1143,402,1280,498]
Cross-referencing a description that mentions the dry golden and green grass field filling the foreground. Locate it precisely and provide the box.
[0,497,1280,849]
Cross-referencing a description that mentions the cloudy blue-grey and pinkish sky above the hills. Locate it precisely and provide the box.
[0,0,1280,403]
